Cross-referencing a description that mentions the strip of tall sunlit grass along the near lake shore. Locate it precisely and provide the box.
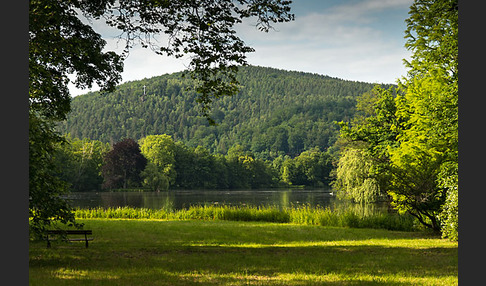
[75,205,415,231]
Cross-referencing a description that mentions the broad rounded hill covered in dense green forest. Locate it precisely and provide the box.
[59,66,390,157]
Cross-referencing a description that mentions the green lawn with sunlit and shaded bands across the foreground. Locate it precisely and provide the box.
[29,219,458,285]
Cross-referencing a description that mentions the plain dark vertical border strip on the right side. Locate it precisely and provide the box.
[459,1,480,285]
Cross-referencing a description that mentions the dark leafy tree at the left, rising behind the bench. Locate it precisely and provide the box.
[29,0,122,234]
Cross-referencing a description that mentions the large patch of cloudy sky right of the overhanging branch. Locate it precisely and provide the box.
[239,0,412,83]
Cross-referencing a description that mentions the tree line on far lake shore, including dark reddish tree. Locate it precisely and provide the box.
[54,134,332,191]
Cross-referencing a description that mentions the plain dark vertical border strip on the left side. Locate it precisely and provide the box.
[0,1,29,285]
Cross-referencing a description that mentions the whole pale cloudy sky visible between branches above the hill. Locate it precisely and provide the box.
[69,0,413,96]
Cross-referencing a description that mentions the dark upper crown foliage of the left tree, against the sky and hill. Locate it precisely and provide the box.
[29,0,123,120]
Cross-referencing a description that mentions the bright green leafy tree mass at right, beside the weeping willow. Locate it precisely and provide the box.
[341,0,458,236]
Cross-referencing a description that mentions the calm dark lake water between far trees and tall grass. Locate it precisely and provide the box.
[63,189,336,209]
